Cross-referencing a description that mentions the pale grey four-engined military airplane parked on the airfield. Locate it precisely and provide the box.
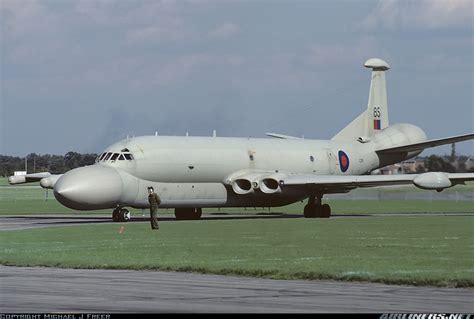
[9,58,474,222]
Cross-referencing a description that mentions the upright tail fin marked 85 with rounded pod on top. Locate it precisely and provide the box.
[332,58,390,141]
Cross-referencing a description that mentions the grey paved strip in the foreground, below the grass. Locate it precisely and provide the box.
[0,266,474,313]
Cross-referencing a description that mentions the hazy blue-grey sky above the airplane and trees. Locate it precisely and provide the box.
[0,0,474,156]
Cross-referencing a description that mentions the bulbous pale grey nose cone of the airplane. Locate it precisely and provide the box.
[54,165,123,210]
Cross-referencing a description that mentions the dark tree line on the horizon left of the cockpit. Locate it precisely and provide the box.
[0,152,97,177]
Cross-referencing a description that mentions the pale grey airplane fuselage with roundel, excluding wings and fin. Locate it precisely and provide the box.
[54,124,426,210]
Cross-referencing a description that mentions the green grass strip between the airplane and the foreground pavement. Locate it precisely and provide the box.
[0,216,474,287]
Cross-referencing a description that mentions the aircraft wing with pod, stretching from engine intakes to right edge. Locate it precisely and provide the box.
[280,172,474,193]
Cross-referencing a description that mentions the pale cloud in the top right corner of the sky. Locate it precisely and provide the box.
[362,0,473,30]
